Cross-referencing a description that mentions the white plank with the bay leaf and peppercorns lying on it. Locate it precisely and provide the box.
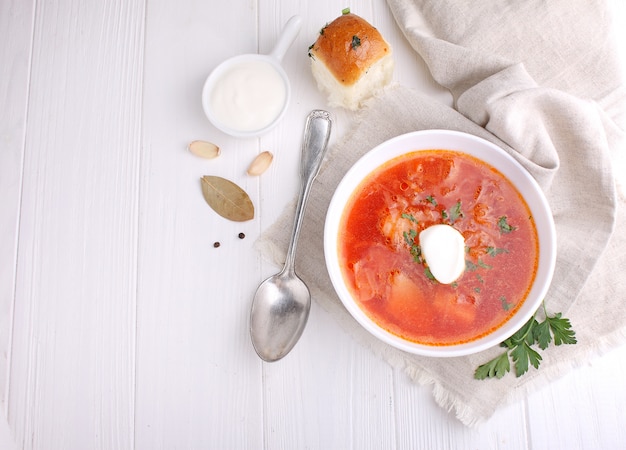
[135,0,263,449]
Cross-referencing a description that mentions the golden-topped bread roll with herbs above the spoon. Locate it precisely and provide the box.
[309,12,394,110]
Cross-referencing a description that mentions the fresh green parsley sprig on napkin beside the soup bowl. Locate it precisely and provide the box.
[474,303,577,380]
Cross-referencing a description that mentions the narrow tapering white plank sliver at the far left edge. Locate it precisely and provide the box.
[0,0,34,414]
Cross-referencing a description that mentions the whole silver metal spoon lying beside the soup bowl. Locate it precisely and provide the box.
[250,110,331,362]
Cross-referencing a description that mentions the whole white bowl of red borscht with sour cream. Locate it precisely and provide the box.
[324,130,556,357]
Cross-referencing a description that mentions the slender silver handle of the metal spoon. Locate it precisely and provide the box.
[283,110,332,273]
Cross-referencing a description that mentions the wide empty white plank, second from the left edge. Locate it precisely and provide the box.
[9,2,143,449]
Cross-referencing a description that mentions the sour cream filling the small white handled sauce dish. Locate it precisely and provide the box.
[210,59,287,131]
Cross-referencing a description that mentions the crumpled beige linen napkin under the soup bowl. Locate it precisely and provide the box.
[257,0,626,424]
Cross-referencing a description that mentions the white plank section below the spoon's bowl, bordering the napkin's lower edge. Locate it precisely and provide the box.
[263,304,396,449]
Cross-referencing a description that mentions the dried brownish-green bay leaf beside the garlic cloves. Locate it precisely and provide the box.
[201,175,254,222]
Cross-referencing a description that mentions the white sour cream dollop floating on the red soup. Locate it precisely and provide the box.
[419,224,465,284]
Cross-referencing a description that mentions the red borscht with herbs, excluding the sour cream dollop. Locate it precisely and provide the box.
[338,150,539,345]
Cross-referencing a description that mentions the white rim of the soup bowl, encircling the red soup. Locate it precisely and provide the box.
[324,129,557,357]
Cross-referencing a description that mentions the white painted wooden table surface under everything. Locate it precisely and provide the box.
[0,0,626,450]
